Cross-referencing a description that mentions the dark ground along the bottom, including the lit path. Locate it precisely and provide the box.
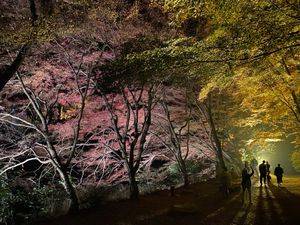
[35,176,300,225]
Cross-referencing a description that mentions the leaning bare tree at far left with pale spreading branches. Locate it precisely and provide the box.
[0,42,90,213]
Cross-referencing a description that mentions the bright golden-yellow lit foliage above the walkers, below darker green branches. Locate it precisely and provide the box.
[227,54,299,147]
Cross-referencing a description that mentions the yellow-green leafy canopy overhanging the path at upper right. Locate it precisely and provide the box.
[106,0,300,163]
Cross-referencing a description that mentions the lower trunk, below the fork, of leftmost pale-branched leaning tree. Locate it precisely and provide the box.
[58,170,79,214]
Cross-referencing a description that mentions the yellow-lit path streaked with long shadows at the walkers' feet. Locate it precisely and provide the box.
[210,178,300,225]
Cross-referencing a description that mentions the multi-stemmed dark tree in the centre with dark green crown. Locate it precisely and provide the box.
[94,37,173,199]
